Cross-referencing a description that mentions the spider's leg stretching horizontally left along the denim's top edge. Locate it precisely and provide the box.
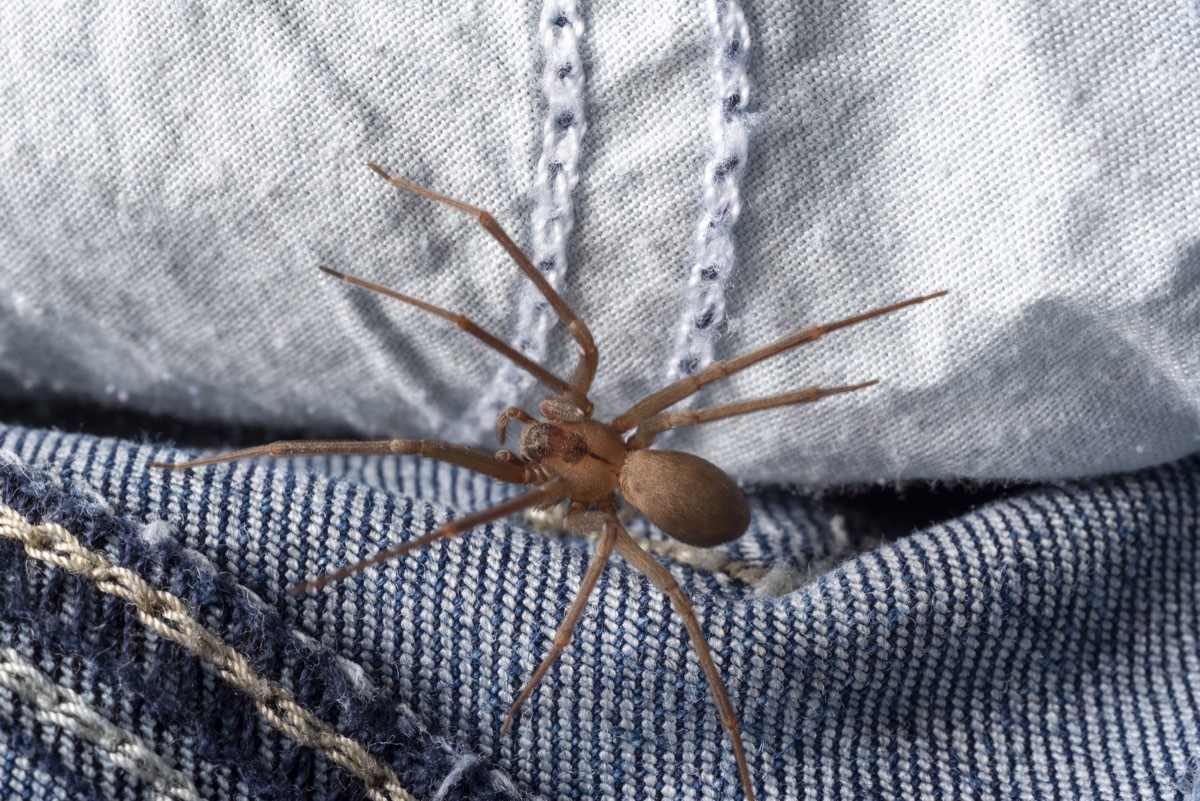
[150,439,540,484]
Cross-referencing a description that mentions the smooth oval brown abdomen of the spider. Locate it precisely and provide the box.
[618,450,750,548]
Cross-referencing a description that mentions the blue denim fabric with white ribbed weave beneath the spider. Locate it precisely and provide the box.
[0,428,1200,800]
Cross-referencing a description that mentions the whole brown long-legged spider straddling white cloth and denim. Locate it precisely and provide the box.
[150,162,946,801]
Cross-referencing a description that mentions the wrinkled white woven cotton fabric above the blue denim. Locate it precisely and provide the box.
[0,0,1200,484]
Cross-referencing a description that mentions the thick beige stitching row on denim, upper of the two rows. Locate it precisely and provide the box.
[0,504,415,801]
